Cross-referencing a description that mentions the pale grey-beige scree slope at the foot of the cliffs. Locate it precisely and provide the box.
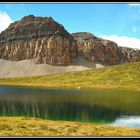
[0,57,102,78]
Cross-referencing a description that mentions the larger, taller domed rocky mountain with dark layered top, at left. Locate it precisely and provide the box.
[0,15,77,65]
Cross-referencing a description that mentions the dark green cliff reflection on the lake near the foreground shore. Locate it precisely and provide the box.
[0,101,120,122]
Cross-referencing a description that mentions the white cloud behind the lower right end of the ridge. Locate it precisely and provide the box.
[100,35,140,49]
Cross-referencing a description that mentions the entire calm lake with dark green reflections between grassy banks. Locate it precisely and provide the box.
[0,86,140,128]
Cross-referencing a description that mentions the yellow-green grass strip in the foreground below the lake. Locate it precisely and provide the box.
[0,117,140,136]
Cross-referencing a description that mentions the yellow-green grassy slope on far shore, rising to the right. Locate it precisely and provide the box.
[0,62,140,90]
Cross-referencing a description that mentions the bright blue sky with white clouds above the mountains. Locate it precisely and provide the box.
[0,3,140,49]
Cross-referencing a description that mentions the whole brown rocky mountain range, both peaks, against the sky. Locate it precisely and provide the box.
[0,15,140,66]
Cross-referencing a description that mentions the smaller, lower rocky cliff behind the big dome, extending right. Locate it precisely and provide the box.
[72,32,140,65]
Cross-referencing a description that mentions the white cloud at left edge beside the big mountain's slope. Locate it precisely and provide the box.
[0,11,12,32]
